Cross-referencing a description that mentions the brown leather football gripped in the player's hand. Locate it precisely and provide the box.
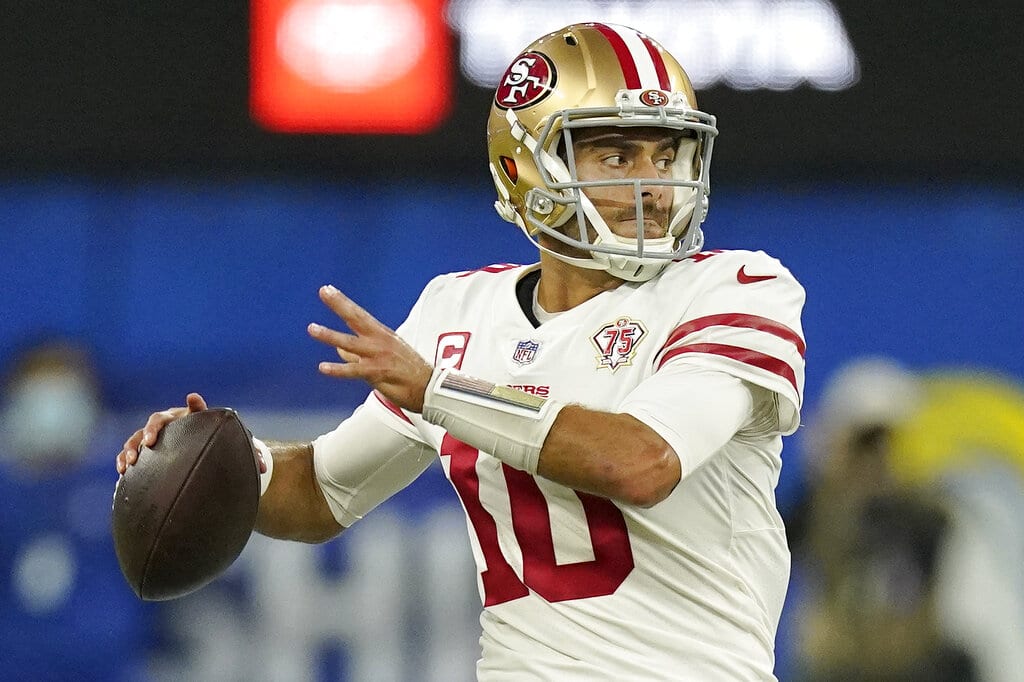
[112,409,259,601]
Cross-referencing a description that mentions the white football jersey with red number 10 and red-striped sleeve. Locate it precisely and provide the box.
[356,251,804,682]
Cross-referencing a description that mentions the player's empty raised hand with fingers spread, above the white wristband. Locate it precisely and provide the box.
[307,285,433,413]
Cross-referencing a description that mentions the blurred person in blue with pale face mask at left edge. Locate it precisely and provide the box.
[0,340,153,681]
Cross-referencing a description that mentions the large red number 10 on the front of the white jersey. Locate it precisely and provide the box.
[441,434,633,606]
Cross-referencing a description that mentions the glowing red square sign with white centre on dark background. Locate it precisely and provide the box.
[250,0,453,134]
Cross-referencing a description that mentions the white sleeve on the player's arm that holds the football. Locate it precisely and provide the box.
[313,398,435,527]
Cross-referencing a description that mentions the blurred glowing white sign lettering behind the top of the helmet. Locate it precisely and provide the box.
[447,0,859,90]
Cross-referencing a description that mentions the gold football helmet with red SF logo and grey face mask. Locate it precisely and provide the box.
[487,24,718,282]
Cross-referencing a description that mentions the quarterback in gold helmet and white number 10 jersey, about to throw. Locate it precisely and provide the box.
[117,24,805,682]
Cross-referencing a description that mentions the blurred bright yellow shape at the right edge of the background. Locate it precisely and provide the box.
[891,371,1024,483]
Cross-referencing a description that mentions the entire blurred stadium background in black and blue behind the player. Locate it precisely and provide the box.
[0,0,1024,681]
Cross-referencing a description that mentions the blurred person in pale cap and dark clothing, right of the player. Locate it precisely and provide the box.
[786,359,981,682]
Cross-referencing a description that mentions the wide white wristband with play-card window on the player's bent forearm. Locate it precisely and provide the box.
[423,370,565,474]
